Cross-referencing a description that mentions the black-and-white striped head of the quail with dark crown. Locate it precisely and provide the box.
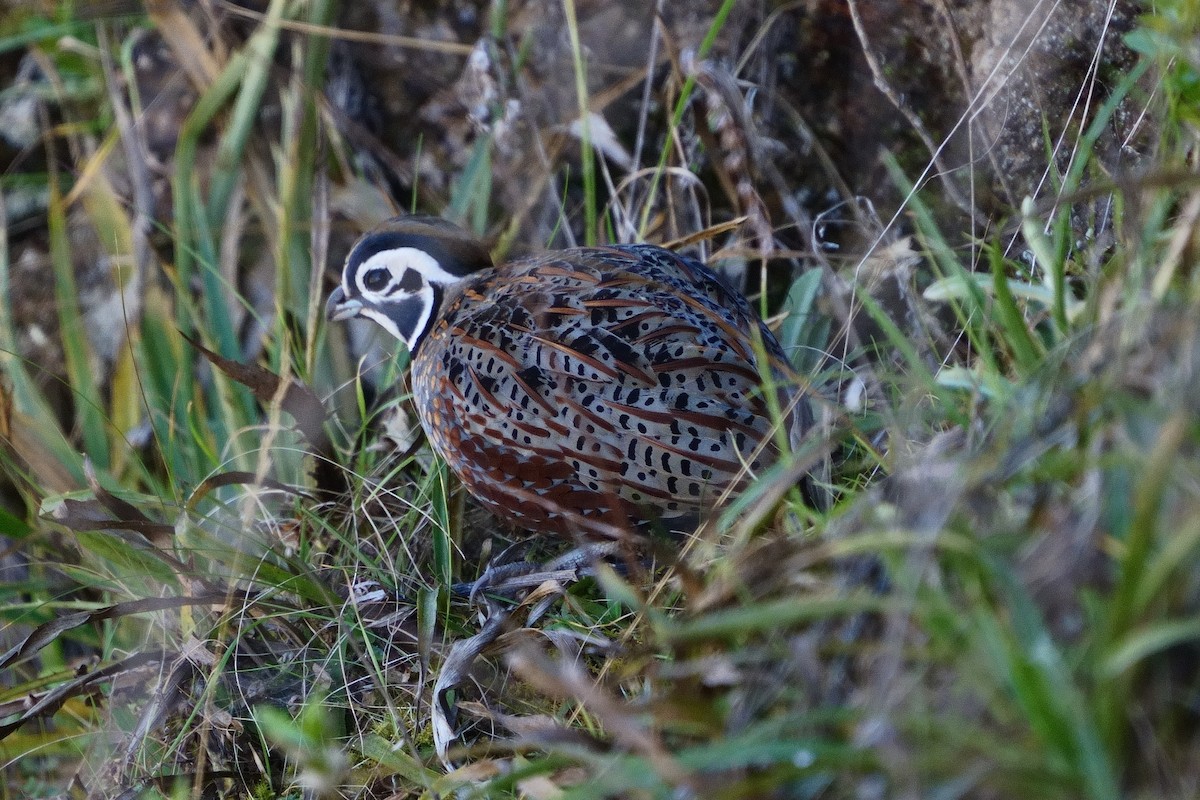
[325,216,492,353]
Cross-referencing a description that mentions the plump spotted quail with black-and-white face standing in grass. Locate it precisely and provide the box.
[328,217,811,536]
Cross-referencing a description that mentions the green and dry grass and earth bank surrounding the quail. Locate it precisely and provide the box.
[0,0,1200,800]
